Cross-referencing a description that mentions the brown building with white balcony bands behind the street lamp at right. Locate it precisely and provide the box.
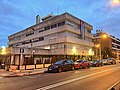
[94,30,120,60]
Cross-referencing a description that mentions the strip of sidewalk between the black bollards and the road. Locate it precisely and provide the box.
[0,68,47,77]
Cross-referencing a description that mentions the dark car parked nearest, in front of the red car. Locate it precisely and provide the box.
[48,60,74,72]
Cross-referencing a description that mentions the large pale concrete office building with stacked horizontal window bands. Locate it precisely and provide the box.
[8,13,94,64]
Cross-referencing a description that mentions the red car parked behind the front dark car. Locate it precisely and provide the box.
[74,60,90,69]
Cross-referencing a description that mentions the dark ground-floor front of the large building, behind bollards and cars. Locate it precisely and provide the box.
[1,54,92,70]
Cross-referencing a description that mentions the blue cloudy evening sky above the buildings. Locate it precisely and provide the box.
[0,0,120,47]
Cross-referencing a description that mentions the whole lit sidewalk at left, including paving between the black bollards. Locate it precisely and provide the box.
[0,64,50,77]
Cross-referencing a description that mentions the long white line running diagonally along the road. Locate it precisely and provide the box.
[36,67,120,90]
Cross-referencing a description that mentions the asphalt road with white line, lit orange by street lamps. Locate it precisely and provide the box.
[0,63,120,90]
